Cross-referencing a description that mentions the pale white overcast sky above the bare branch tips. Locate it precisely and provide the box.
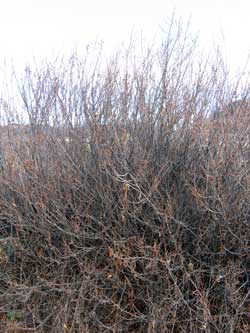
[0,0,250,76]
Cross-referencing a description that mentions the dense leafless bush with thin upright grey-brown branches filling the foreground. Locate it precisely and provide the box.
[0,21,250,333]
